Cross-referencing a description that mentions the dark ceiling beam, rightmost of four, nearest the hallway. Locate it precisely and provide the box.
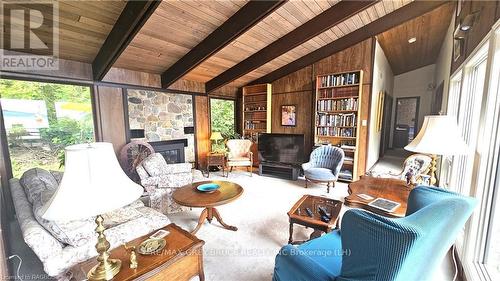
[249,0,449,84]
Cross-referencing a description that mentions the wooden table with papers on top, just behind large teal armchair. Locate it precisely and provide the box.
[344,176,412,218]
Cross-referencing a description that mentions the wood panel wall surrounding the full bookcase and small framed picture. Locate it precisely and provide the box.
[272,38,375,175]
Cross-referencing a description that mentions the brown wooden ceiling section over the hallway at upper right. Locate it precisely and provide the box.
[377,3,454,75]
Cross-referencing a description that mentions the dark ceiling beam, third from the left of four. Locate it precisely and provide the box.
[206,0,378,92]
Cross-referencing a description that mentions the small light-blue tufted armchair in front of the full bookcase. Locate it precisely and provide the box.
[302,145,344,193]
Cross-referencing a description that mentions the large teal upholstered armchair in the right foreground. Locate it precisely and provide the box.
[273,186,476,281]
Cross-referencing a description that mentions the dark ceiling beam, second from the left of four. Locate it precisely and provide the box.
[161,0,286,88]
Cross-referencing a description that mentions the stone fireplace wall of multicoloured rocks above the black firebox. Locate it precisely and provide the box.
[128,90,195,162]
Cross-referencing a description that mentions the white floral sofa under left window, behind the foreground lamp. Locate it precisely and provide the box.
[10,168,170,278]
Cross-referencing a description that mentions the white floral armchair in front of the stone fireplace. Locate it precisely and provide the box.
[136,153,193,214]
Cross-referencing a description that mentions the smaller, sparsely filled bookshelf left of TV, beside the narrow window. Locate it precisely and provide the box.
[242,84,272,142]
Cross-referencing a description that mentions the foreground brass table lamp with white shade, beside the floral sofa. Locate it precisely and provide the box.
[42,142,143,280]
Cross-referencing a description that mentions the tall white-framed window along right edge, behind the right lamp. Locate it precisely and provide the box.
[448,20,500,280]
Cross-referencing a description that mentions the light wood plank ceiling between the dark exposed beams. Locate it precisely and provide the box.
[0,0,452,90]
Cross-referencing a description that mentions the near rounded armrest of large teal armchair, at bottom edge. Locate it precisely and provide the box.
[273,245,336,281]
